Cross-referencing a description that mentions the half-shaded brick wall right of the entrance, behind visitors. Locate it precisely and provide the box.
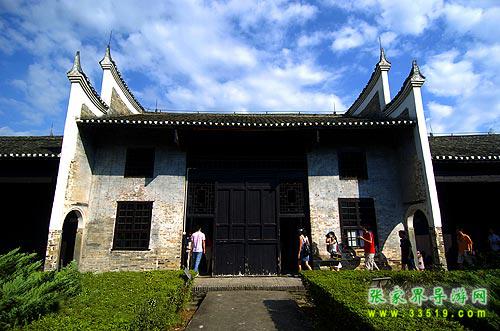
[308,145,404,264]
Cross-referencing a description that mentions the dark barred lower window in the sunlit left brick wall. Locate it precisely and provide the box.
[113,201,153,250]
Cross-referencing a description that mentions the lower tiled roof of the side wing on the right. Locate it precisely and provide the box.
[429,134,500,161]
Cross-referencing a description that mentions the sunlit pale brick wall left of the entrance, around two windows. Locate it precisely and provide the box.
[80,143,186,271]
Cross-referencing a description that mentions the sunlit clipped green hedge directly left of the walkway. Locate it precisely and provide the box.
[25,271,190,330]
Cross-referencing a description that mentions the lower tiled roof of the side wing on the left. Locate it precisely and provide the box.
[0,136,62,158]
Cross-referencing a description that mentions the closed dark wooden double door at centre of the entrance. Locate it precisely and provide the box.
[214,181,280,275]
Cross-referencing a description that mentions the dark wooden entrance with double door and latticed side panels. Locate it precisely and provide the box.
[187,171,309,275]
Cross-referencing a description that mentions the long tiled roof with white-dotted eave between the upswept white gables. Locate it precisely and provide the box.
[79,112,415,127]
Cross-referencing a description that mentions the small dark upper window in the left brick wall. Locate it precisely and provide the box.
[124,148,155,178]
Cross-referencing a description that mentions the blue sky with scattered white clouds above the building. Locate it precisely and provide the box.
[0,0,500,135]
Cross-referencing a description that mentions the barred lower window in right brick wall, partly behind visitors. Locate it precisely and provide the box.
[339,198,377,247]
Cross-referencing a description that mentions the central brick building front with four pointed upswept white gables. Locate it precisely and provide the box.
[0,47,500,275]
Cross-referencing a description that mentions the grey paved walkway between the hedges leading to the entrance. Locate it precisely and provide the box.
[186,292,312,331]
